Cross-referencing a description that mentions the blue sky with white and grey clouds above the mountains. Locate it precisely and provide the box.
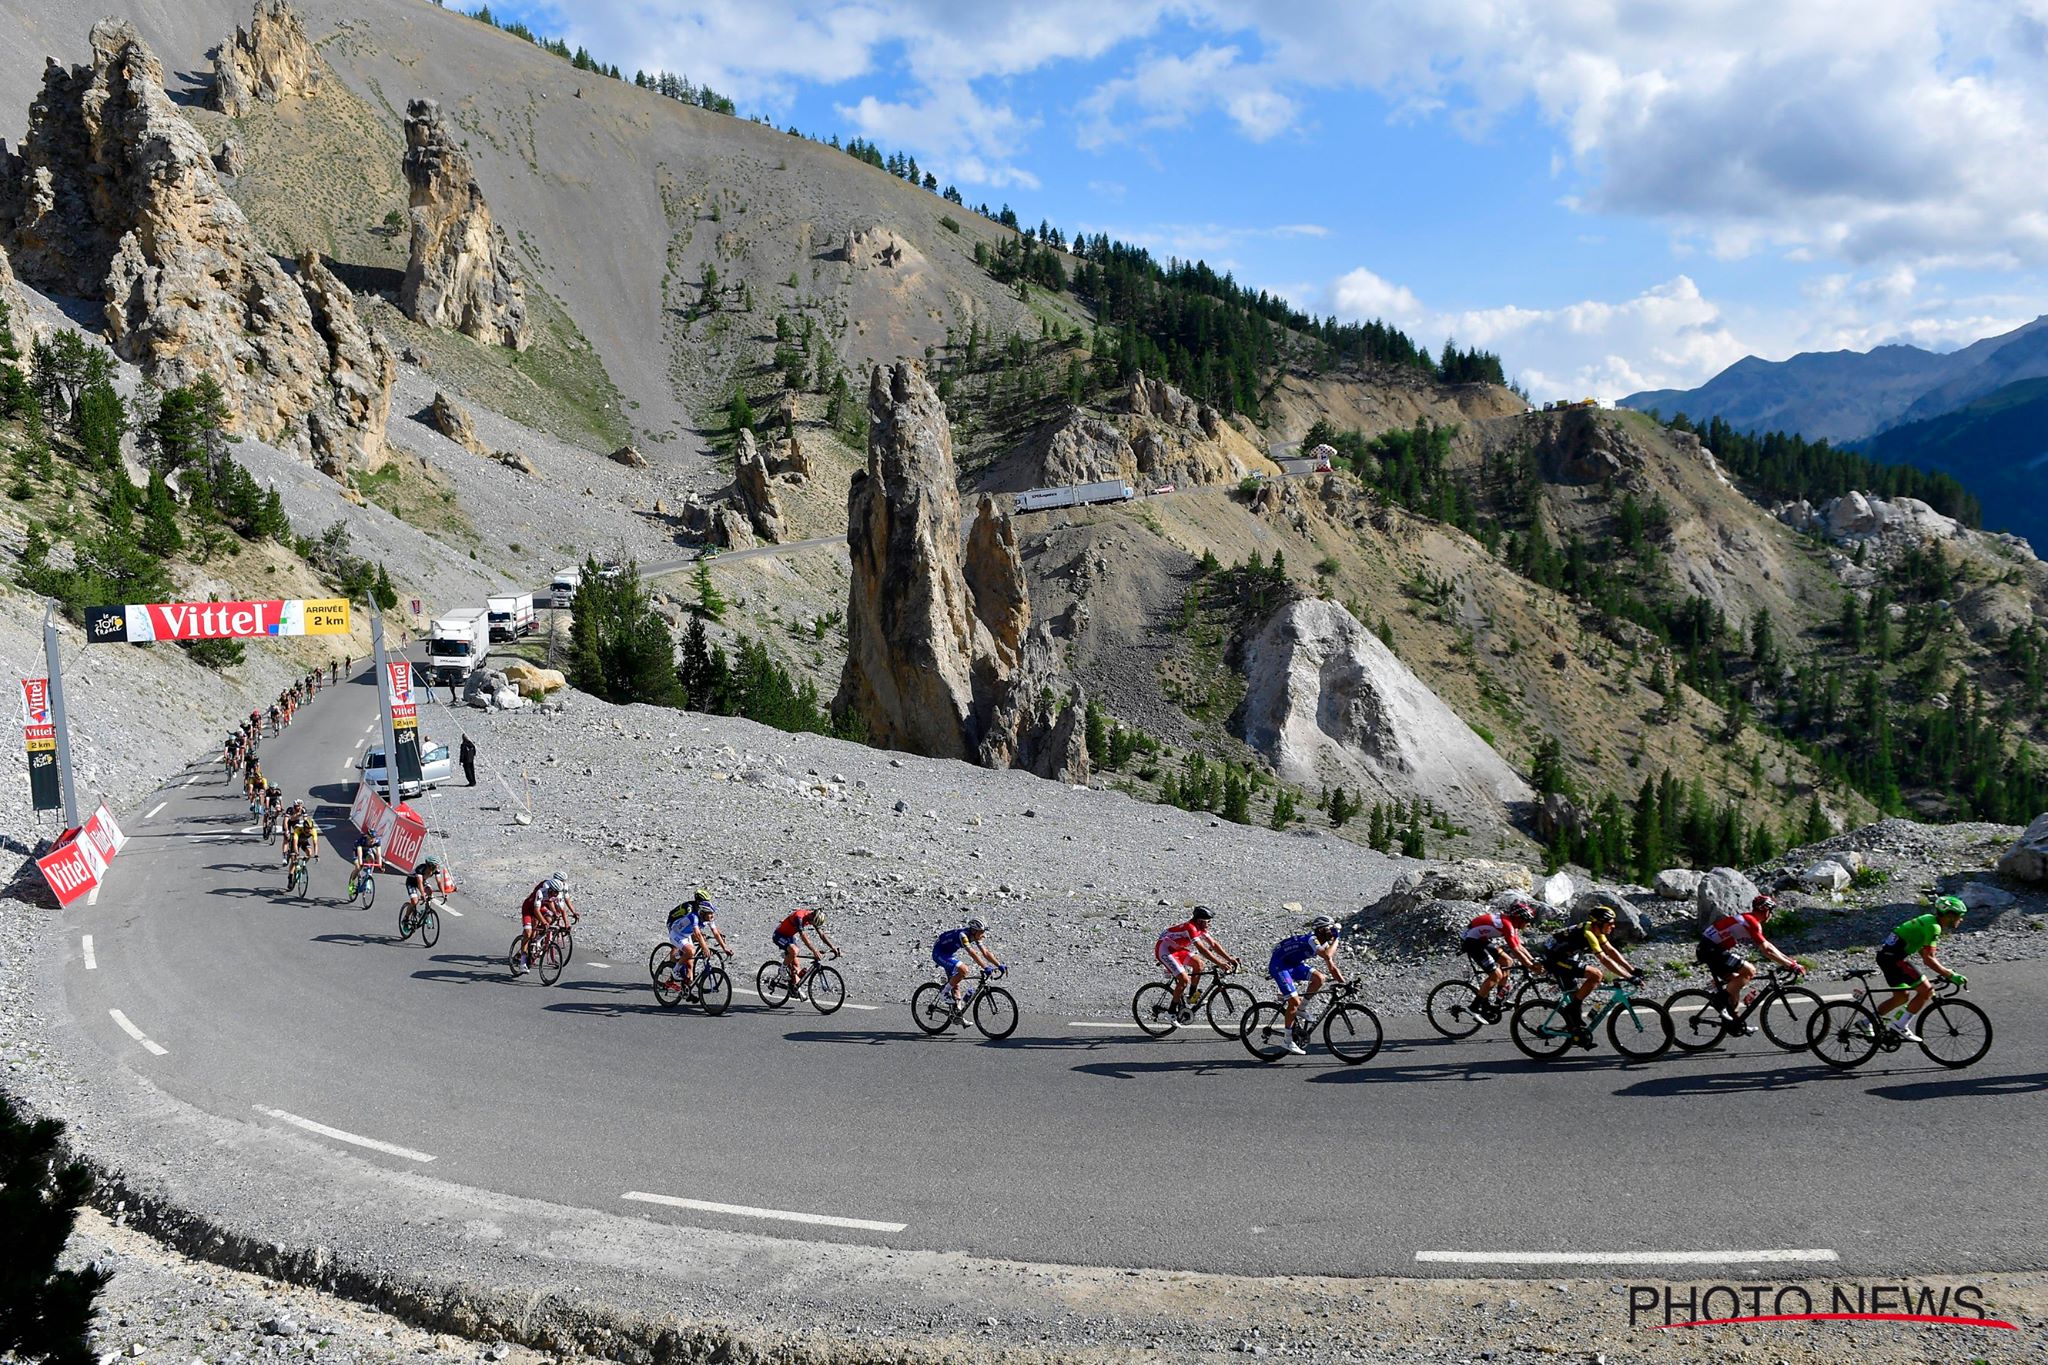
[492,0,2048,399]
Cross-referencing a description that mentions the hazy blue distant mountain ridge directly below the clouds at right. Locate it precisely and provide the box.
[1620,315,2048,444]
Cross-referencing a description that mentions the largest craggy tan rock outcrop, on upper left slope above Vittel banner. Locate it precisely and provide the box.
[0,20,395,473]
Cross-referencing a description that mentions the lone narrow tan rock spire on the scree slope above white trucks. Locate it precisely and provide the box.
[397,100,532,350]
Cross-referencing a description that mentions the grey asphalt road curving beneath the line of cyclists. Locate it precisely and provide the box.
[48,675,2048,1275]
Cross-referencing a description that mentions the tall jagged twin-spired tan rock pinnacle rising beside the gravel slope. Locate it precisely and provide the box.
[836,362,1087,782]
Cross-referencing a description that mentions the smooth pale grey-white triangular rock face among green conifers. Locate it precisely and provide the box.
[1233,600,1530,821]
